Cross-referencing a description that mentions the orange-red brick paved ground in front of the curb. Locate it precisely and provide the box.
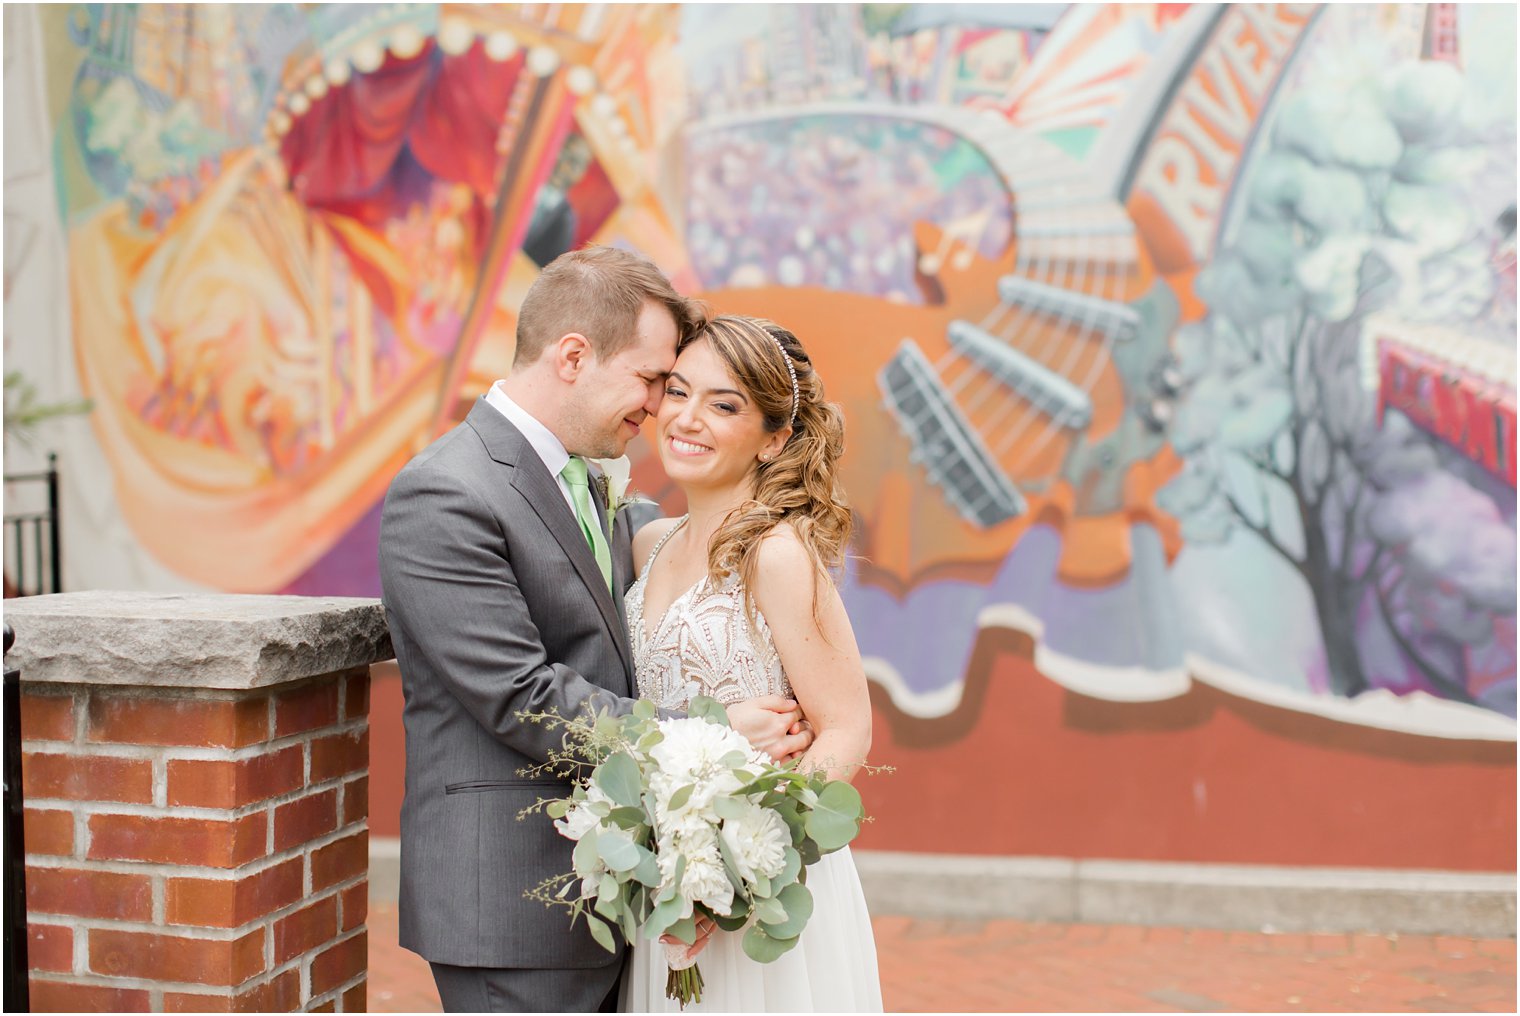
[369,903,1515,1013]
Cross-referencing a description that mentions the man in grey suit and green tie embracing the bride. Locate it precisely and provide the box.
[380,246,810,1011]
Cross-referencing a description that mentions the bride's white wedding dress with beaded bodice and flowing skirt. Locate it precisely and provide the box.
[622,522,882,1013]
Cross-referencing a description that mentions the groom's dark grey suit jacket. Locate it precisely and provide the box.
[380,398,637,969]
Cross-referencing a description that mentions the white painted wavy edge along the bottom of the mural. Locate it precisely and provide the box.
[865,604,1515,741]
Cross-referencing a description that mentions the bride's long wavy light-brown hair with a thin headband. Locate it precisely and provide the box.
[690,315,853,621]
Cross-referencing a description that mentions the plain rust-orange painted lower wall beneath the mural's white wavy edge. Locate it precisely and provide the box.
[369,650,1515,872]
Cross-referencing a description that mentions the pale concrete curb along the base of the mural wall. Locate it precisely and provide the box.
[361,838,1515,938]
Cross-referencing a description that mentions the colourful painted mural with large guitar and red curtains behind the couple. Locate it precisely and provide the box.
[8,3,1515,867]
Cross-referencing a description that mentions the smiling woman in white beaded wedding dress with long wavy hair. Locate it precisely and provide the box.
[623,315,882,1011]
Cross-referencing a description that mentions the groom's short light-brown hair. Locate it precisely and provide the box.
[512,246,707,367]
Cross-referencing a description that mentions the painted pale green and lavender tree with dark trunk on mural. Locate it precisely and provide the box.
[1163,62,1515,709]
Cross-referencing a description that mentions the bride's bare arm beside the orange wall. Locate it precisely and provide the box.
[752,525,871,780]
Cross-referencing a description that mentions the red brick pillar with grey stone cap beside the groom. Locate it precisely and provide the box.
[6,593,391,1013]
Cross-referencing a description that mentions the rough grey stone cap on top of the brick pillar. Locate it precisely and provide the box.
[5,590,395,689]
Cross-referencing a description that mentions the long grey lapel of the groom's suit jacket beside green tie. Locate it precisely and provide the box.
[468,398,634,687]
